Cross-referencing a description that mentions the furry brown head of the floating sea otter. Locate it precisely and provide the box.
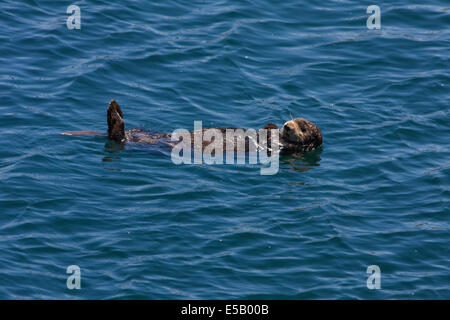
[280,118,322,151]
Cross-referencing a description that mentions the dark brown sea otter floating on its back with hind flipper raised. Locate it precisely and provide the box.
[62,100,322,154]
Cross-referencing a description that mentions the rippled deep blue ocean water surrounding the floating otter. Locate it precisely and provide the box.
[0,0,450,299]
